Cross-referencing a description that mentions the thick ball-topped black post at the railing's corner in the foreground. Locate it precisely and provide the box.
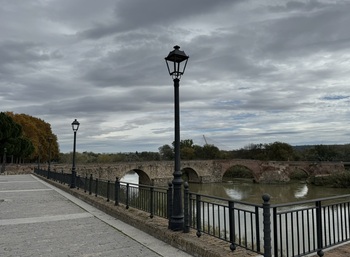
[262,194,272,257]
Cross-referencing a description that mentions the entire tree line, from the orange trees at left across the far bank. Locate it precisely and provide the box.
[0,112,350,163]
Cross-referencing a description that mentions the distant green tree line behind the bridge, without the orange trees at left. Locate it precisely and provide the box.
[59,139,350,163]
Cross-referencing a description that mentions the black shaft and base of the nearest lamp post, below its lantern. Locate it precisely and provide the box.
[170,78,184,231]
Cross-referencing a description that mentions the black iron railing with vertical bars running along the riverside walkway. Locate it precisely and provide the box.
[34,169,350,257]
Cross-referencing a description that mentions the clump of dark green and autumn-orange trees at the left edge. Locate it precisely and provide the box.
[0,112,59,163]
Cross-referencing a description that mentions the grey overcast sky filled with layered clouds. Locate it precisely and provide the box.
[0,0,350,152]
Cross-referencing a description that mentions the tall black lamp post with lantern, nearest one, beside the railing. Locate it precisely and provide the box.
[165,45,189,231]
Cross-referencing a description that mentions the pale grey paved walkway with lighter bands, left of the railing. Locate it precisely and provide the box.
[0,175,190,257]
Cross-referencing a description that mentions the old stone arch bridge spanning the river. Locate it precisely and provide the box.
[45,159,345,186]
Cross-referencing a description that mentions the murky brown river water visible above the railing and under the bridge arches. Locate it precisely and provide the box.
[121,172,350,204]
